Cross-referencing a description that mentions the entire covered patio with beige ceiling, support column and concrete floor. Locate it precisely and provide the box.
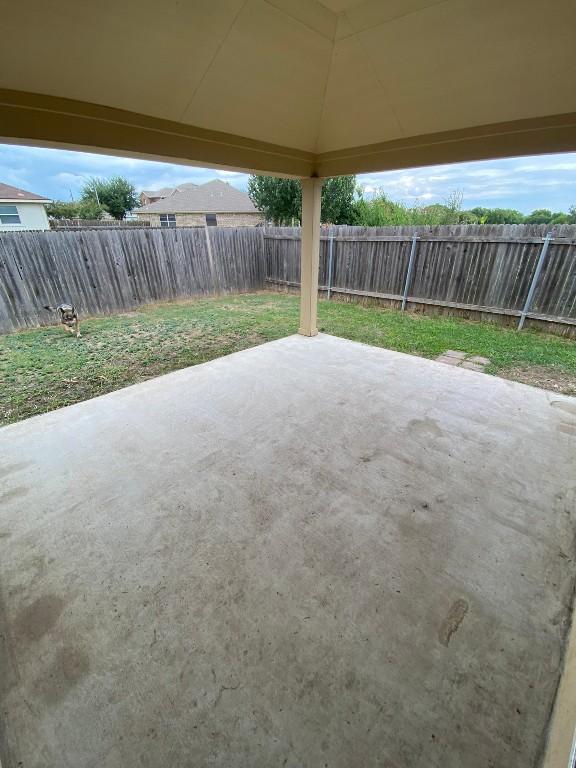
[0,0,576,768]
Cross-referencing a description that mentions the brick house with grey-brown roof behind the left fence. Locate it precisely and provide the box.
[134,179,264,227]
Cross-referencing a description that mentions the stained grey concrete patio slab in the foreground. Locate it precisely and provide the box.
[0,336,576,768]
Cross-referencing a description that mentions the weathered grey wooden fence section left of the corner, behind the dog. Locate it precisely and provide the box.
[0,227,265,333]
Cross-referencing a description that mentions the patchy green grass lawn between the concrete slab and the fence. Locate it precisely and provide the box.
[0,293,576,424]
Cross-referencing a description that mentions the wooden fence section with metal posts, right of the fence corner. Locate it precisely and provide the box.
[264,219,576,335]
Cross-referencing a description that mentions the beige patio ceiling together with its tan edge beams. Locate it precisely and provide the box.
[0,0,576,176]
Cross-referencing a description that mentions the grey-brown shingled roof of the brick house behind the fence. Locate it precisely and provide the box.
[135,179,258,213]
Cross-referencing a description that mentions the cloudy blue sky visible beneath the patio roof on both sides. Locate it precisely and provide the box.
[0,144,576,213]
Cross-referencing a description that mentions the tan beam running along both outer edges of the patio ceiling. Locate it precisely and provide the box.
[0,89,576,178]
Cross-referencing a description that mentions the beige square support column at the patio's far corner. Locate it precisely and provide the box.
[298,178,322,336]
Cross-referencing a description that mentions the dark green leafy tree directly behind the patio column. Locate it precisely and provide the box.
[248,176,356,225]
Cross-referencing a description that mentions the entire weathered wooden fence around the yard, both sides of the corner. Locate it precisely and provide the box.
[0,225,576,332]
